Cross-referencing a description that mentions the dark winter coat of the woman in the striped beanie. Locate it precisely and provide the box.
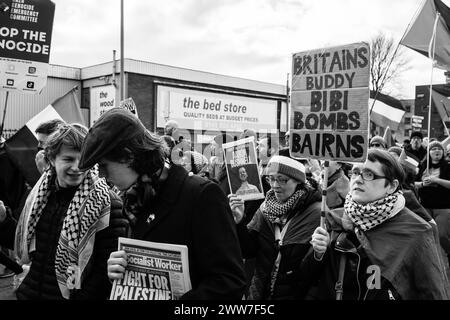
[237,187,321,300]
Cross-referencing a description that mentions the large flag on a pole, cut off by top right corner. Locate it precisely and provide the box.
[400,0,450,70]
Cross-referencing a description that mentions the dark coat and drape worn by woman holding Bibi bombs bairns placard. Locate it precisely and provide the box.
[308,207,450,300]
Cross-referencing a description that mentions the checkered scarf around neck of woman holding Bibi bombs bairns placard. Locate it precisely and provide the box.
[344,190,405,231]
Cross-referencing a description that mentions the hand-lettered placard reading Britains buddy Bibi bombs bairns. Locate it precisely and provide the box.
[289,42,370,162]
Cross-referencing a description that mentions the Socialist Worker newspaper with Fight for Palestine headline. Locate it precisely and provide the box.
[110,238,192,300]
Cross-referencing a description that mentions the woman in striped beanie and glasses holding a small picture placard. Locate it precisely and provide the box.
[229,156,321,300]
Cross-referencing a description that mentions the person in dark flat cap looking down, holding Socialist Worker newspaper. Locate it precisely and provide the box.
[80,108,245,300]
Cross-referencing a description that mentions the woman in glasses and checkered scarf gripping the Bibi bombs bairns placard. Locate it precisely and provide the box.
[312,149,449,300]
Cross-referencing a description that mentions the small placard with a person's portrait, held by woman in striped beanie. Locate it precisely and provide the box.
[223,137,264,201]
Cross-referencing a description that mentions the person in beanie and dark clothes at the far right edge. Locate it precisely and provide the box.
[415,141,450,260]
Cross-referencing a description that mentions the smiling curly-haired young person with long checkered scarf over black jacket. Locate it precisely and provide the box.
[0,124,128,300]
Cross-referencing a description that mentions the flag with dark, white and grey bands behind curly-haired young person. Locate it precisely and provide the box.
[5,86,85,186]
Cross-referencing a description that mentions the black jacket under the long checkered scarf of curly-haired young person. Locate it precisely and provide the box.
[0,190,128,300]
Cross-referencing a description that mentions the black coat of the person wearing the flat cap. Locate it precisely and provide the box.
[128,165,245,299]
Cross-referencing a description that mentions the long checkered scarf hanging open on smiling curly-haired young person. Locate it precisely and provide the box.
[16,166,111,299]
